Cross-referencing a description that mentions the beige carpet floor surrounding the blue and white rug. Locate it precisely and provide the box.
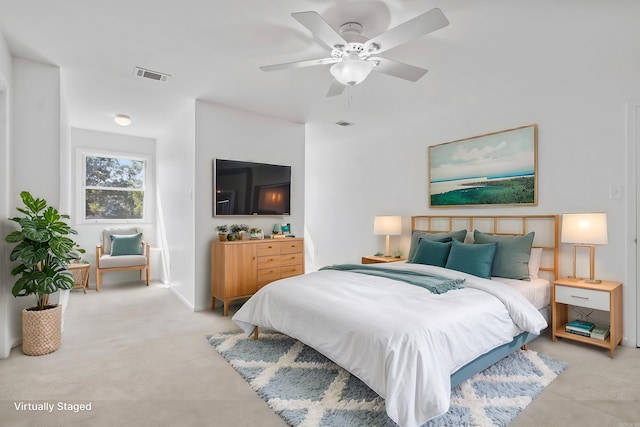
[0,282,640,427]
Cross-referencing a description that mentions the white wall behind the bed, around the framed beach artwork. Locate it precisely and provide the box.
[305,2,640,345]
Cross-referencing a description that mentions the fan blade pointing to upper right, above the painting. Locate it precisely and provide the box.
[364,8,449,54]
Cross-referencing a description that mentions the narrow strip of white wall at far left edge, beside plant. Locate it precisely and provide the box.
[0,28,15,359]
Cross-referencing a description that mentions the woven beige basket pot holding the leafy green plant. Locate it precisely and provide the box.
[22,304,62,356]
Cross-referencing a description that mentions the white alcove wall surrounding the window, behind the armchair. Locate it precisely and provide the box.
[70,128,162,286]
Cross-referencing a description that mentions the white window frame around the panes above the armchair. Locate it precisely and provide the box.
[76,149,153,224]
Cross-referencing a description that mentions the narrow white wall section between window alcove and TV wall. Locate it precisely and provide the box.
[156,101,196,309]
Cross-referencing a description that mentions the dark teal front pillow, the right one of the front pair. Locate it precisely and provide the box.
[445,240,498,279]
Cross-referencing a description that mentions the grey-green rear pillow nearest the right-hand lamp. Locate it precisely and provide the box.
[473,230,535,280]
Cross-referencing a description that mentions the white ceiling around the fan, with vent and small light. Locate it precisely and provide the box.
[0,0,637,138]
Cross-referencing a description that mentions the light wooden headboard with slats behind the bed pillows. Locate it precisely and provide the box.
[411,215,560,280]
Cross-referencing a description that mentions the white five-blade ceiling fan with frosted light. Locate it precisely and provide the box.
[260,8,449,96]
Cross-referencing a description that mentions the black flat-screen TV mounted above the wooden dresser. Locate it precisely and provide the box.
[213,159,291,216]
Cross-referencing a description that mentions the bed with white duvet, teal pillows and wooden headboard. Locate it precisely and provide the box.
[233,215,558,427]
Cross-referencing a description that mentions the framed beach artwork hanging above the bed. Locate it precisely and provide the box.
[428,124,538,208]
